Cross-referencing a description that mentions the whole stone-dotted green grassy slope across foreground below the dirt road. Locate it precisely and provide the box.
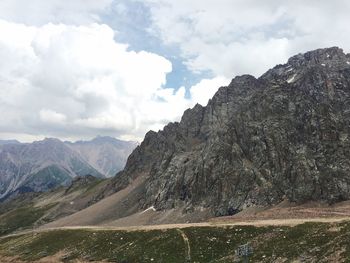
[0,222,350,263]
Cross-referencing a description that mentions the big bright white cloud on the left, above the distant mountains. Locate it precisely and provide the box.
[0,20,227,142]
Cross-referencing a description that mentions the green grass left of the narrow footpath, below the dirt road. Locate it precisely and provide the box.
[0,230,185,262]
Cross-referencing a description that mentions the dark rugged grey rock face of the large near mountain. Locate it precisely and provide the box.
[109,48,350,215]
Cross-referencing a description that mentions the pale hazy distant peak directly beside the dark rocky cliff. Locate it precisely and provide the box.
[66,136,137,177]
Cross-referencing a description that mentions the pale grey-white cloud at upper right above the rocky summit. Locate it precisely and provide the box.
[142,0,350,78]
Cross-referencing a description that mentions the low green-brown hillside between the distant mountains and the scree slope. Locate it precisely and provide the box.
[0,175,109,235]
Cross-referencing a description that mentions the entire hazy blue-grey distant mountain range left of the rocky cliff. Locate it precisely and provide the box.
[0,136,136,198]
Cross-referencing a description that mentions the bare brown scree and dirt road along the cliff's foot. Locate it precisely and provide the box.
[35,198,350,231]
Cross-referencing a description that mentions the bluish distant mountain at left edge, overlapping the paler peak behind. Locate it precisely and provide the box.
[0,138,104,198]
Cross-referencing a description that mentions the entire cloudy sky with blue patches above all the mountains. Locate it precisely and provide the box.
[0,0,350,142]
